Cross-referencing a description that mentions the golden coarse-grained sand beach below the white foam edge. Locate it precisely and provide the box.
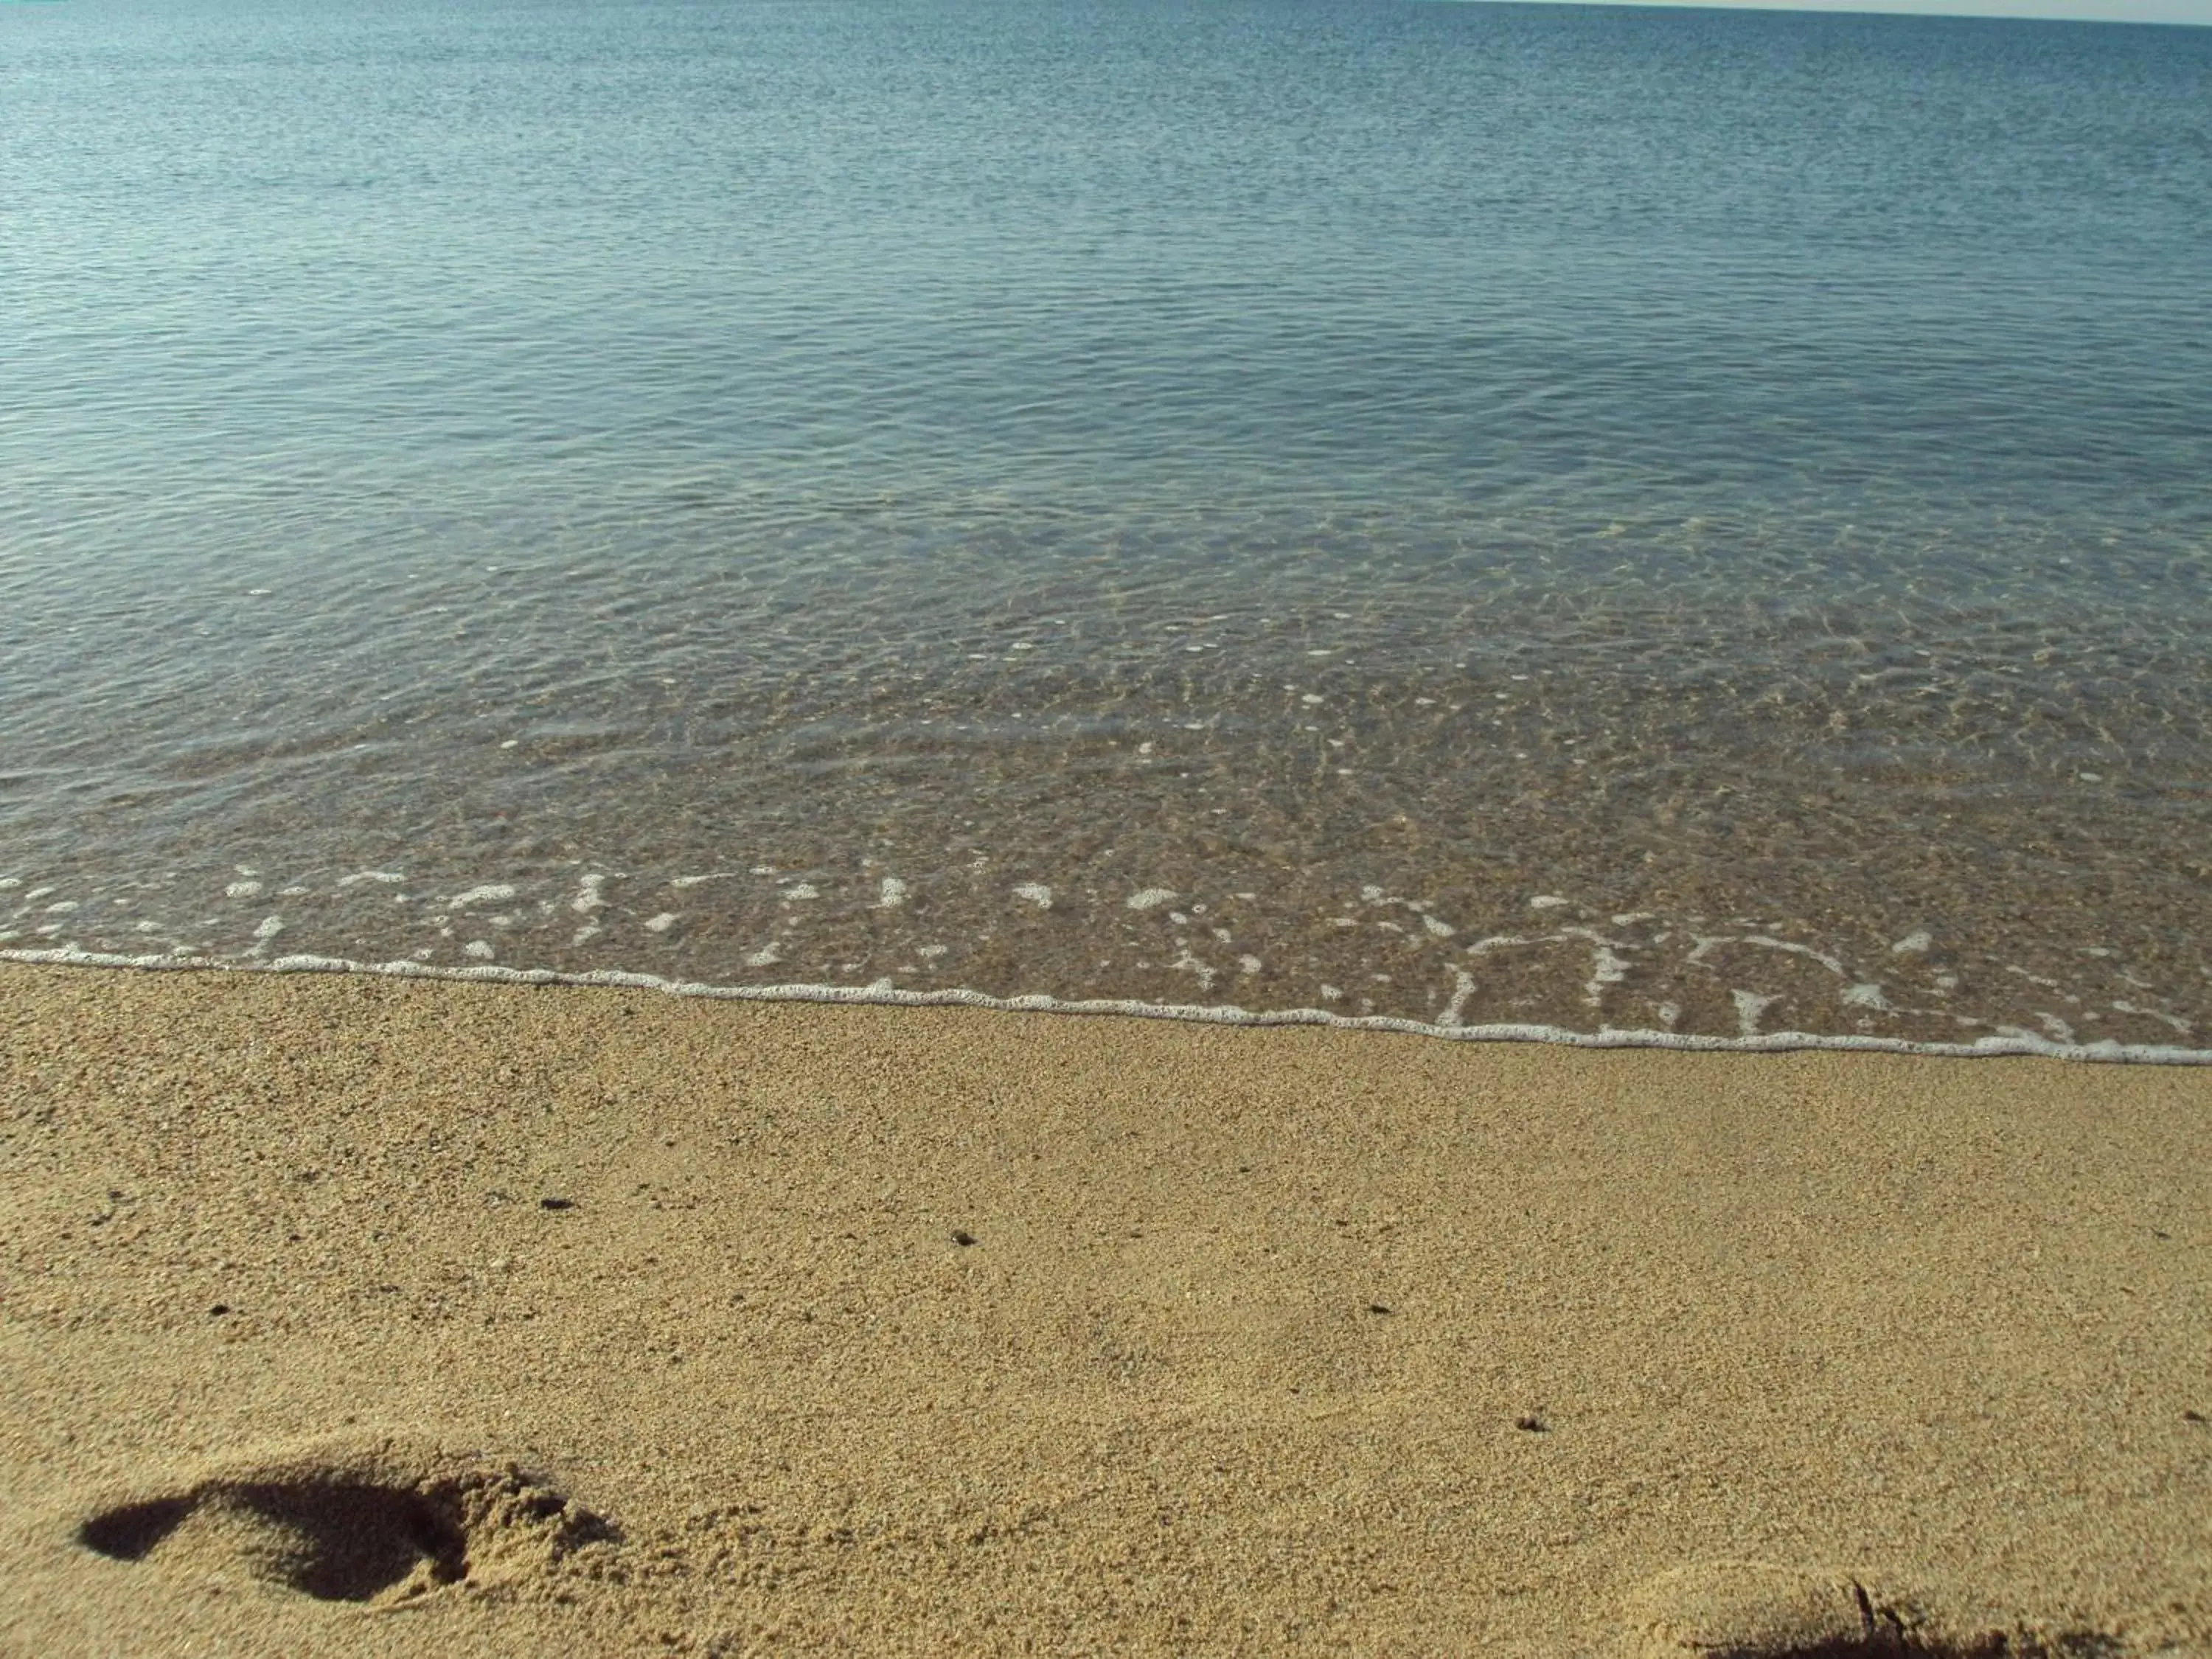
[0,967,2212,1659]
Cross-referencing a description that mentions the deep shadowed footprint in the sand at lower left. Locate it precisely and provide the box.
[77,1440,619,1606]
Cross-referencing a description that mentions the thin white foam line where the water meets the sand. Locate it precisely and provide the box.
[0,947,2212,1066]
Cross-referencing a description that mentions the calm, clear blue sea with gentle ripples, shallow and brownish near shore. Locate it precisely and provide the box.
[0,0,2212,1051]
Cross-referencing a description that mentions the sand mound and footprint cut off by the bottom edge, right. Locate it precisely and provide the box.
[1621,1562,2115,1659]
